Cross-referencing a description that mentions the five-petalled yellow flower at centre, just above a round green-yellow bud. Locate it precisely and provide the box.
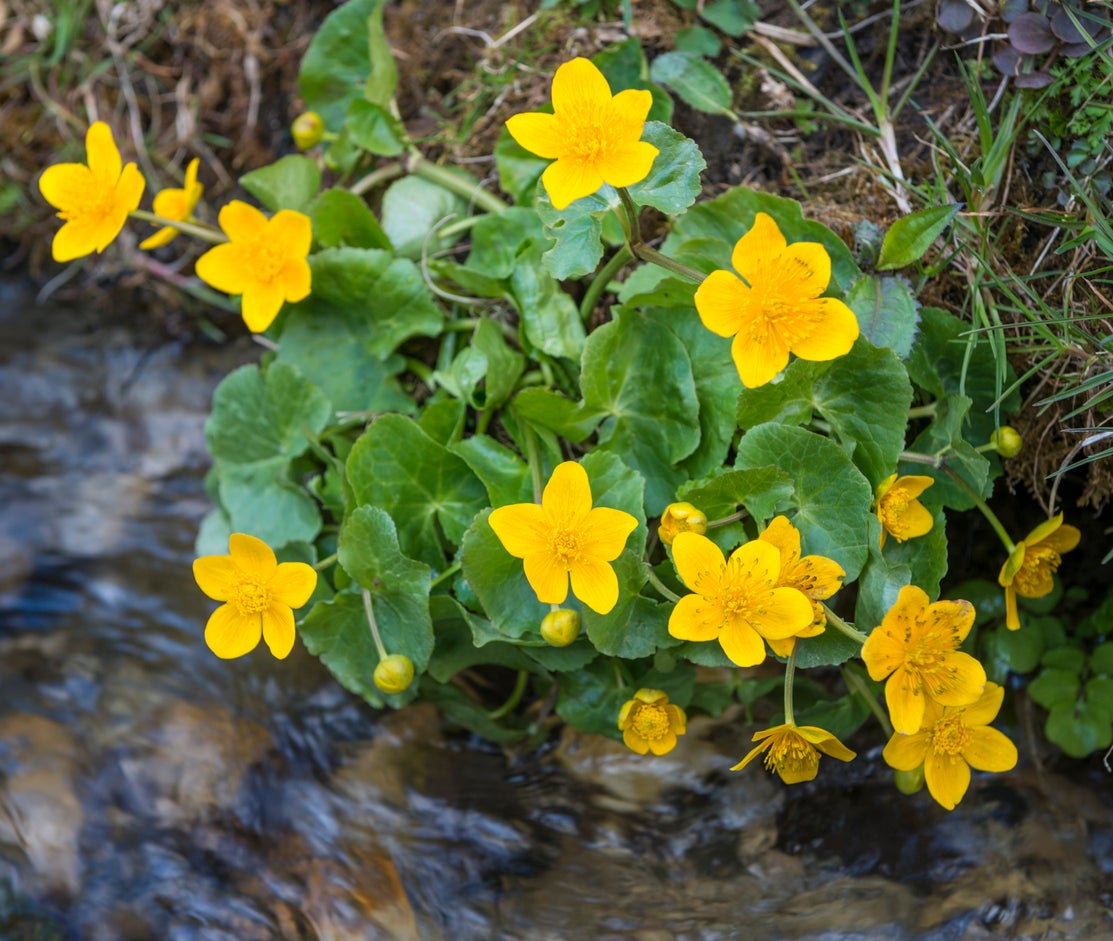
[490,461,638,615]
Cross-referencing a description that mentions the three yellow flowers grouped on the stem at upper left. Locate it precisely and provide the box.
[39,121,313,332]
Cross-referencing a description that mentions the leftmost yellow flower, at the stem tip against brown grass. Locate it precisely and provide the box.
[39,121,146,262]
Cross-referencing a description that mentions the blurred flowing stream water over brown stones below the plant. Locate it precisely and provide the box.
[0,283,1113,941]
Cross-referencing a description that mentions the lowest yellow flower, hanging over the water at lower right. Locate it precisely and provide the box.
[881,683,1016,811]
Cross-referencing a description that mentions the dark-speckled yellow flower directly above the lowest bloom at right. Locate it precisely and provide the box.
[861,585,985,735]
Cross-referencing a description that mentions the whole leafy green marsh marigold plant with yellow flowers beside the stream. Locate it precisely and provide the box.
[30,0,1104,808]
